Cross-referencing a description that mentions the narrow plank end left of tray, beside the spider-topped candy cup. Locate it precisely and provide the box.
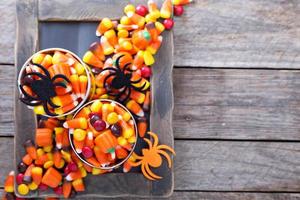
[0,65,15,136]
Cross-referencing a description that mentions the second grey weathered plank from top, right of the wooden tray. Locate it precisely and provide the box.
[173,69,300,140]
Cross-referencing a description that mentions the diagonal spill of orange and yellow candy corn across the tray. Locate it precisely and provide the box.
[3,0,191,199]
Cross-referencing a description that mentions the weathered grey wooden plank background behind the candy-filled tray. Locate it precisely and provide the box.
[0,0,300,200]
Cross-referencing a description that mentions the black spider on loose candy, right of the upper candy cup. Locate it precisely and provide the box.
[101,55,146,103]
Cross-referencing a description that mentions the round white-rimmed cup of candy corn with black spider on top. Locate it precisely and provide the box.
[18,48,91,117]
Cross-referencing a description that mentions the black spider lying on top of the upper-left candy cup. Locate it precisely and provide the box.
[19,63,70,116]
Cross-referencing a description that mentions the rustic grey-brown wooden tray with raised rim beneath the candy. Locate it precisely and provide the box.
[15,0,174,197]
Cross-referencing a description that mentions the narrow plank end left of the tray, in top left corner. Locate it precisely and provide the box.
[0,0,16,64]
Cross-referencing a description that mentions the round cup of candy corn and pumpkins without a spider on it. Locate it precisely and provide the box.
[69,99,138,170]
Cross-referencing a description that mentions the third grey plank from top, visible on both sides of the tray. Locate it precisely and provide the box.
[0,138,300,192]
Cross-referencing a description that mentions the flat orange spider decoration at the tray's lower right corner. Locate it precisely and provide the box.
[131,131,176,181]
